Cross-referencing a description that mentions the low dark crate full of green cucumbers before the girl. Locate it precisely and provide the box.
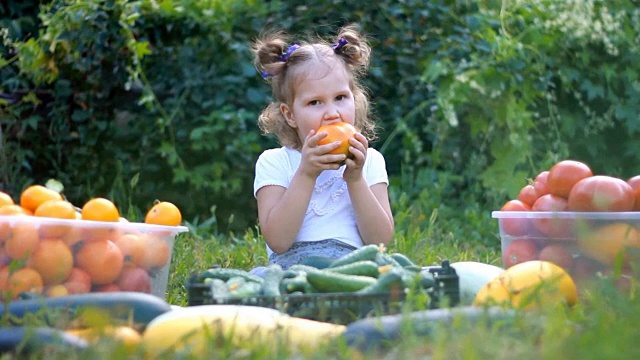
[187,245,459,324]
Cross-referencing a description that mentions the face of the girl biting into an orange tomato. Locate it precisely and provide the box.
[280,64,356,144]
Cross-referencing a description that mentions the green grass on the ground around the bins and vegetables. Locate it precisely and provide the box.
[2,195,640,359]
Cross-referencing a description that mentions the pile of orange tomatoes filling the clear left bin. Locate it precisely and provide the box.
[0,185,182,299]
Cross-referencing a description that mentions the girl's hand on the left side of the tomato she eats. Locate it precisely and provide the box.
[298,130,346,179]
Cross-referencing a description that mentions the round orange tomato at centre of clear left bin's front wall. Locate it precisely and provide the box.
[76,240,124,285]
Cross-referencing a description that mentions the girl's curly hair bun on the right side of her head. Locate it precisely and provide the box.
[334,25,371,72]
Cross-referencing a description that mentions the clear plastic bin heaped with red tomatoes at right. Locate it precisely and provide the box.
[492,160,640,285]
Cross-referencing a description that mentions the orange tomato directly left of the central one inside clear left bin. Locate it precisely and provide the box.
[29,239,73,285]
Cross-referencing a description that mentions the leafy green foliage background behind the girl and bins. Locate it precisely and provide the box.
[0,0,640,236]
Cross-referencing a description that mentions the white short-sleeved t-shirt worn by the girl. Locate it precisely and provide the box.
[253,147,389,255]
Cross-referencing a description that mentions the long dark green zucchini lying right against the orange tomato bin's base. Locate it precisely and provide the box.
[0,291,171,328]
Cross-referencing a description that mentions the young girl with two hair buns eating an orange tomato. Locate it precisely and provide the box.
[253,26,394,272]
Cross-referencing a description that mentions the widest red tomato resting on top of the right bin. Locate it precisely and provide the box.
[568,175,635,211]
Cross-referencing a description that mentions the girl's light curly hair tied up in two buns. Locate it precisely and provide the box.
[252,25,376,150]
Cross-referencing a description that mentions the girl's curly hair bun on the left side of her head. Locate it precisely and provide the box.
[252,32,287,79]
